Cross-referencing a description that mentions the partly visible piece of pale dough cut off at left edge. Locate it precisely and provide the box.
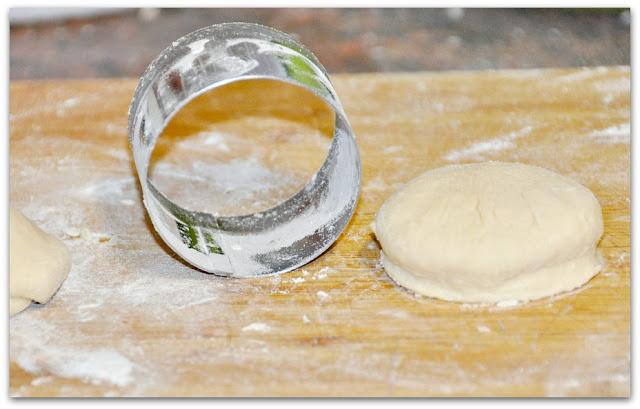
[9,208,71,315]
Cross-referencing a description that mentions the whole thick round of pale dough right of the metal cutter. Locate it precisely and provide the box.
[375,162,603,302]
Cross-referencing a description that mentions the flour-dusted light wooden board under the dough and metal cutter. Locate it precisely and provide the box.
[10,67,630,396]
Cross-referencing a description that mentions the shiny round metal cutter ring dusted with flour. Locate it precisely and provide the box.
[129,23,361,277]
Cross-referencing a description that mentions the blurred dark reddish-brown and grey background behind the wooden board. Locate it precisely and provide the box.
[10,8,630,79]
